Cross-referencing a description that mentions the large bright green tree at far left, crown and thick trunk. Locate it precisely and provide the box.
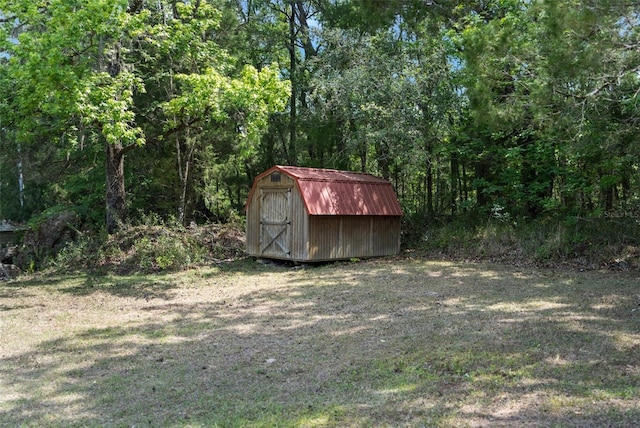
[0,1,144,232]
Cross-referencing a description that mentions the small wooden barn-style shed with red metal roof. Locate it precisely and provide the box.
[246,165,402,262]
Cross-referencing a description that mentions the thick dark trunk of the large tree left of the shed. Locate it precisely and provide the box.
[106,143,127,234]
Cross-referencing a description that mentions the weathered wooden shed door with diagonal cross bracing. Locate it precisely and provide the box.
[260,189,291,258]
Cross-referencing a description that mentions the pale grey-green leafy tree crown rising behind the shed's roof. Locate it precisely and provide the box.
[308,23,457,186]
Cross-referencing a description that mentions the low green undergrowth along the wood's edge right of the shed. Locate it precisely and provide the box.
[403,213,640,268]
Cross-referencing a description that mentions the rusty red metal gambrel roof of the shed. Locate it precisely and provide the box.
[252,165,402,216]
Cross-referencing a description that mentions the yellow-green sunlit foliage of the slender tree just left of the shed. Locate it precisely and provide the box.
[161,65,290,222]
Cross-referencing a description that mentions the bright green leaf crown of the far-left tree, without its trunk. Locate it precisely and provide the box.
[0,0,143,143]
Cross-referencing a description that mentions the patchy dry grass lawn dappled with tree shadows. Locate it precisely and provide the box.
[0,258,640,427]
